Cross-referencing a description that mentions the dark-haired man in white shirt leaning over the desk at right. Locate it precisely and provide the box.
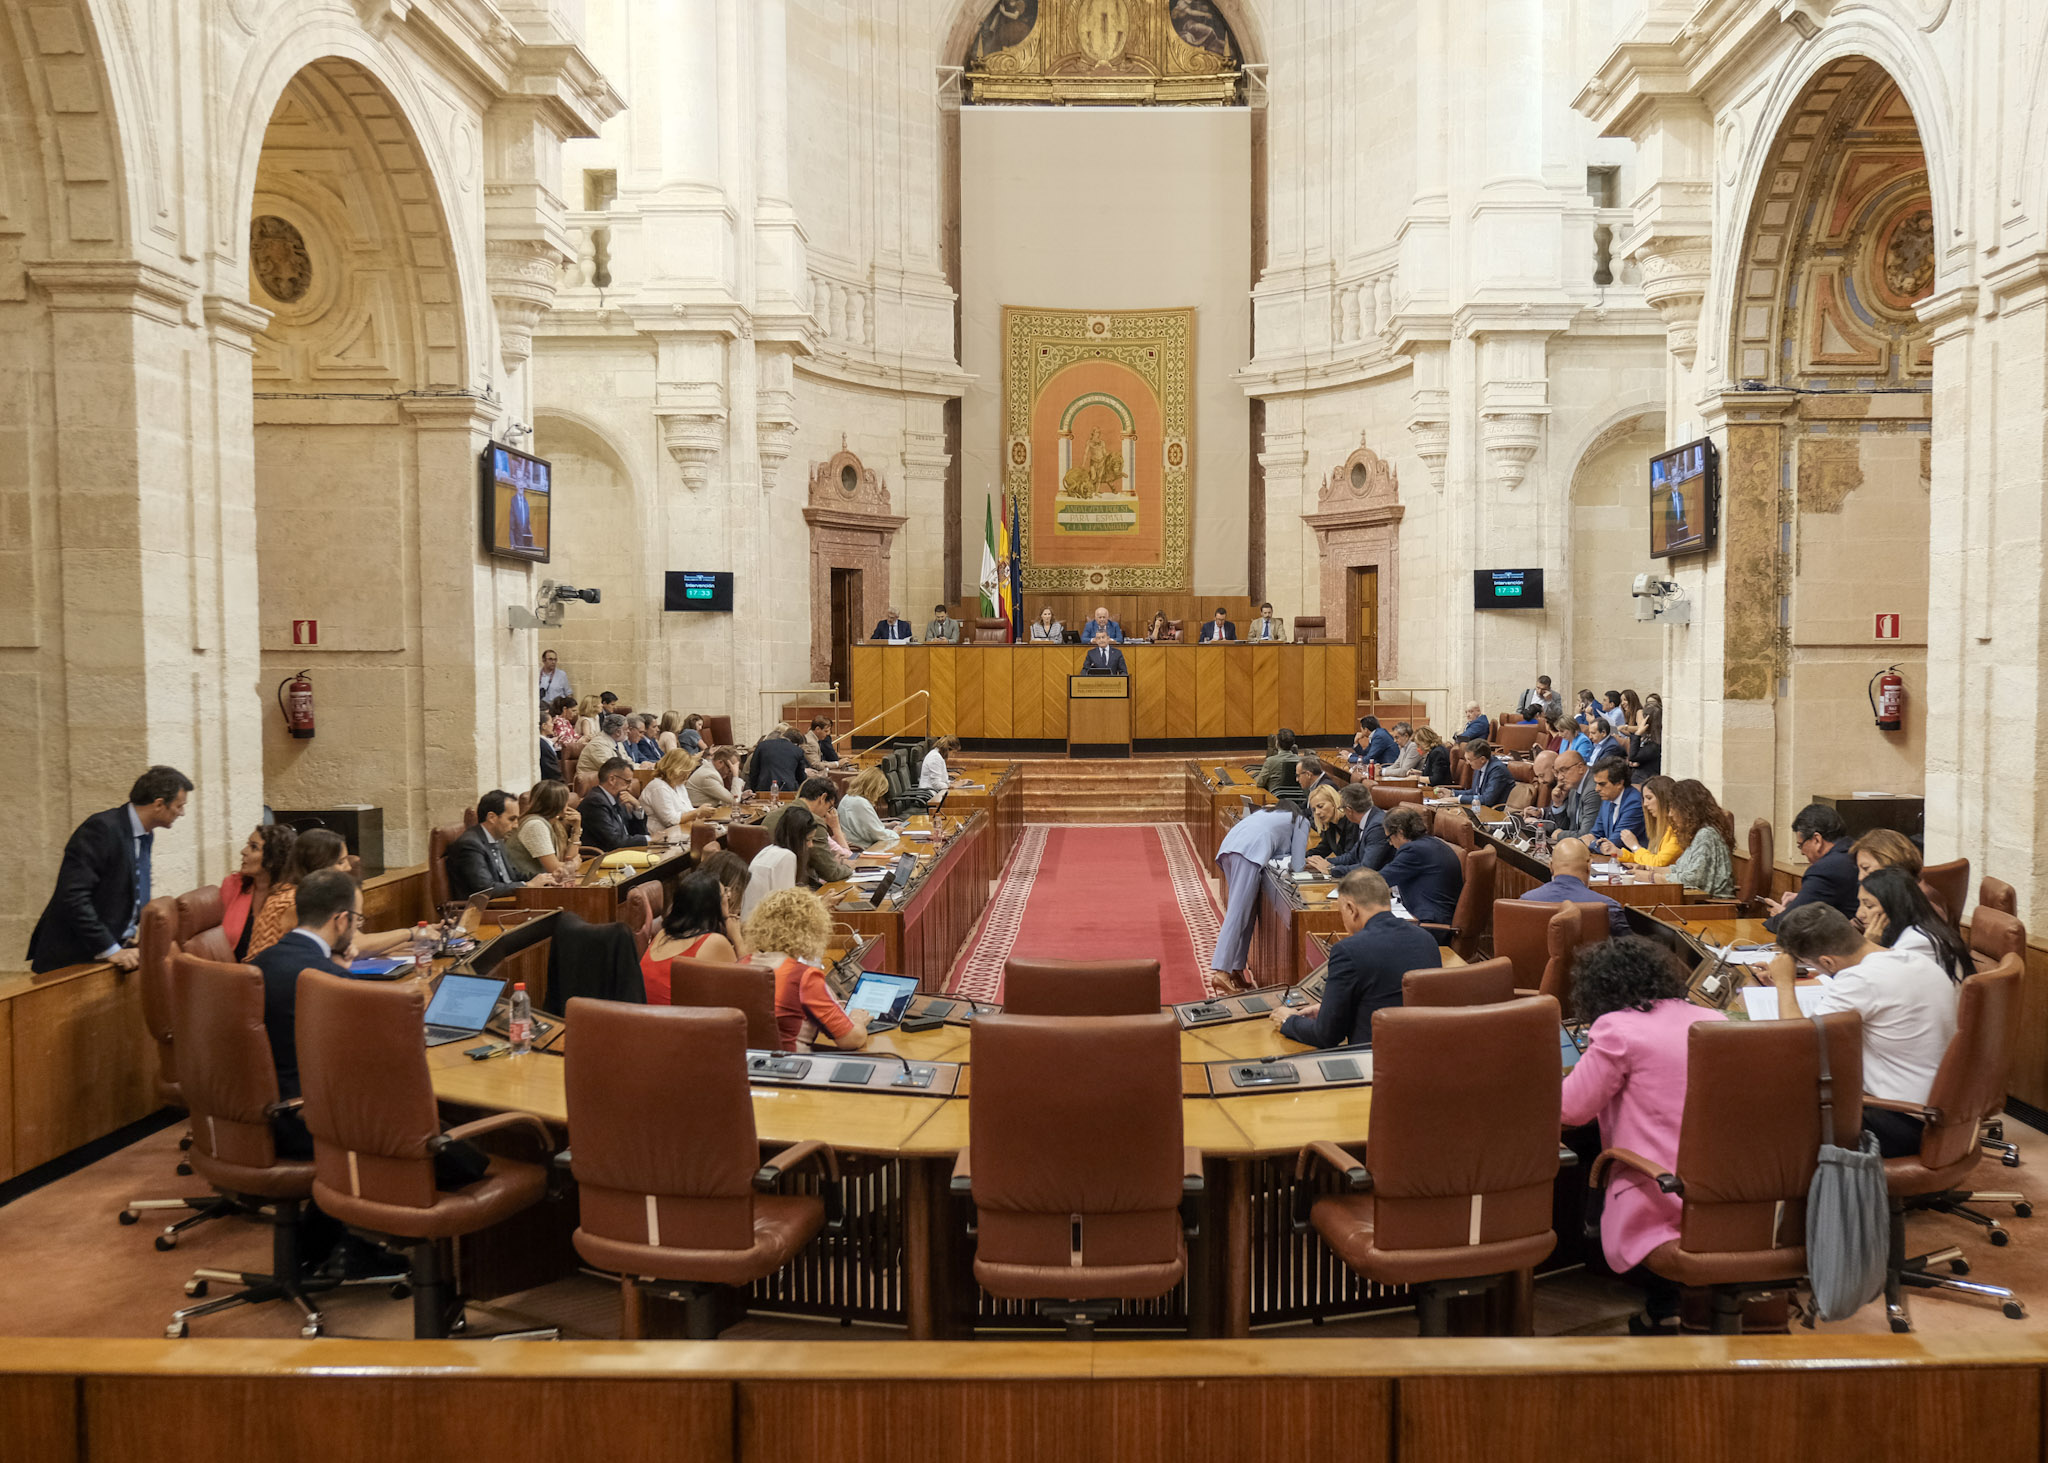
[1769,900,1956,1158]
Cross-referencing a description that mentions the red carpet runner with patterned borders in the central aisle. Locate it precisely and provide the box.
[952,824,1219,1004]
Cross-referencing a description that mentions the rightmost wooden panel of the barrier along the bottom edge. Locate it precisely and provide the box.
[1395,1367,2042,1463]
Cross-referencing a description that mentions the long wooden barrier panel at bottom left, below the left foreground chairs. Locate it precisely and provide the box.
[84,1375,733,1463]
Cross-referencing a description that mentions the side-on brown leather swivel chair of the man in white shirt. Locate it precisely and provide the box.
[1864,955,2032,1332]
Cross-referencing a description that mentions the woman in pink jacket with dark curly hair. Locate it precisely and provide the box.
[1561,934,1726,1336]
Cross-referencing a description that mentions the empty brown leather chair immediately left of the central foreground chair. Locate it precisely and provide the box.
[563,998,840,1340]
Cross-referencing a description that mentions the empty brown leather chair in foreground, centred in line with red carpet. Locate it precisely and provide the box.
[952,1010,1196,1338]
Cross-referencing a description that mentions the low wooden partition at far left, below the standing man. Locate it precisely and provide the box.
[8,965,158,1172]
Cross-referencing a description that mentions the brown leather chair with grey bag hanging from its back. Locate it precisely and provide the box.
[1589,1012,1864,1336]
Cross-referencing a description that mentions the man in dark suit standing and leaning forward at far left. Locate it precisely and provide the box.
[29,766,193,973]
